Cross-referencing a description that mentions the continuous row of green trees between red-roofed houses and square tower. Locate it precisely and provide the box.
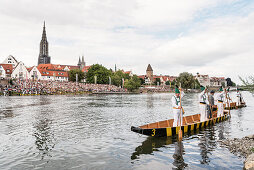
[68,64,141,91]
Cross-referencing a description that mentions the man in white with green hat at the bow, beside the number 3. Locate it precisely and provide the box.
[171,87,184,127]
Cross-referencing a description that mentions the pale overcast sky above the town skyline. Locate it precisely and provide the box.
[0,0,254,83]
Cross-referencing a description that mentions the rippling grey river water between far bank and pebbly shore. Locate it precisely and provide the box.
[0,92,254,170]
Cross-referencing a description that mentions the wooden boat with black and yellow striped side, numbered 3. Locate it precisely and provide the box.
[131,110,229,136]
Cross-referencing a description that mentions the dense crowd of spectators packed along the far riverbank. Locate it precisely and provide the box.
[0,80,126,95]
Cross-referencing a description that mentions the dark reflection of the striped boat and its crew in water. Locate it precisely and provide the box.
[131,124,221,169]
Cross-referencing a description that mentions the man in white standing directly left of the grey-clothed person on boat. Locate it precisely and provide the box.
[199,86,209,122]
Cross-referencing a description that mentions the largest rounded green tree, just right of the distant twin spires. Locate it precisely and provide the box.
[86,64,112,84]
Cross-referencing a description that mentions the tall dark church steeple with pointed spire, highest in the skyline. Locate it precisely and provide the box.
[38,21,50,65]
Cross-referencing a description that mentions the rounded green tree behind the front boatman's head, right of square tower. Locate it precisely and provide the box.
[176,72,195,90]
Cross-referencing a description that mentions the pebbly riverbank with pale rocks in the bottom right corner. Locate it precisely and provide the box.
[221,134,254,170]
